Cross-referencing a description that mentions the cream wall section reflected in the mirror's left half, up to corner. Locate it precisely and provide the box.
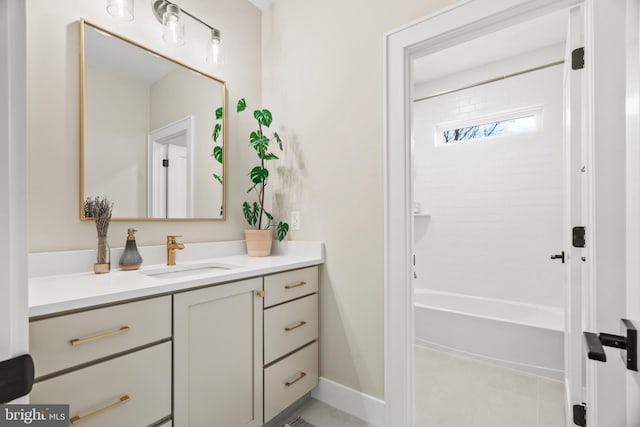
[84,65,150,218]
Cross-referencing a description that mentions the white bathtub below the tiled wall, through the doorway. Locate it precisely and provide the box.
[414,289,564,381]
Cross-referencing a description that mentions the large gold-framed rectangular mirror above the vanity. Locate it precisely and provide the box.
[80,20,226,220]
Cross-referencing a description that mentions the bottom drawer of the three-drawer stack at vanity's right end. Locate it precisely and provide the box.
[264,342,318,422]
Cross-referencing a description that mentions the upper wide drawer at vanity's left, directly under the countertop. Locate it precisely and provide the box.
[29,296,171,378]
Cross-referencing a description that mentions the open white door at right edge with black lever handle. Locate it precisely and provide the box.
[585,0,640,427]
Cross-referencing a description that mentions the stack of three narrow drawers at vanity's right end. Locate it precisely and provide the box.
[264,267,318,422]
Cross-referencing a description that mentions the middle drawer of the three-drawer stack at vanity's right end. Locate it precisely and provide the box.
[264,294,318,364]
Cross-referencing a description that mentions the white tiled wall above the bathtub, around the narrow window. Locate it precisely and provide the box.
[414,64,563,307]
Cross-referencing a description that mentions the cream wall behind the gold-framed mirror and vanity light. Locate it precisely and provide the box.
[26,0,262,252]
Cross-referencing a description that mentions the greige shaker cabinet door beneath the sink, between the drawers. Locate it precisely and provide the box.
[173,278,262,427]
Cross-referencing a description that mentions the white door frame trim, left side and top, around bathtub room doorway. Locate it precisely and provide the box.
[383,0,593,426]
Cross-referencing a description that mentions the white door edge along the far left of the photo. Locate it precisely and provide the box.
[0,0,29,401]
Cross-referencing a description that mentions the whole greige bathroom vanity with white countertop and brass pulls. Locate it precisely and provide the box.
[30,242,323,427]
